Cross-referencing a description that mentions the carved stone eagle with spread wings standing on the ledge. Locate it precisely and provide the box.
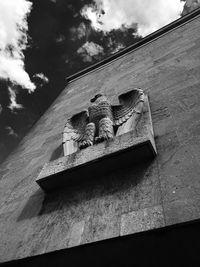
[63,89,144,155]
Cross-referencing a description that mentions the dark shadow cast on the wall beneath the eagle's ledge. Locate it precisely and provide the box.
[18,160,156,221]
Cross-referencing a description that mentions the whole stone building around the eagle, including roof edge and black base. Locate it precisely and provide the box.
[0,9,200,266]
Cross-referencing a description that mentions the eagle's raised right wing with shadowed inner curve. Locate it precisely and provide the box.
[112,89,144,126]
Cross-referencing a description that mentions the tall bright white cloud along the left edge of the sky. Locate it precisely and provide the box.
[0,0,35,92]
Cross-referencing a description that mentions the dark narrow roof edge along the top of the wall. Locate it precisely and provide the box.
[66,8,200,83]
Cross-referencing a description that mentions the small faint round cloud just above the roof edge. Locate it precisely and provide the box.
[77,42,103,62]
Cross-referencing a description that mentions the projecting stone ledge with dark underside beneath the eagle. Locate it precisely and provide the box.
[36,127,157,191]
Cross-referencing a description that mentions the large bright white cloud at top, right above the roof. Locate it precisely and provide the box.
[81,0,184,36]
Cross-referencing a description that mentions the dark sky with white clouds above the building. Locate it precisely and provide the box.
[0,0,197,162]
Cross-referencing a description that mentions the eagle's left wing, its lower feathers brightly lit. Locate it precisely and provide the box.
[63,110,89,156]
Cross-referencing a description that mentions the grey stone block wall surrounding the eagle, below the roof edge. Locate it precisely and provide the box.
[0,13,200,262]
